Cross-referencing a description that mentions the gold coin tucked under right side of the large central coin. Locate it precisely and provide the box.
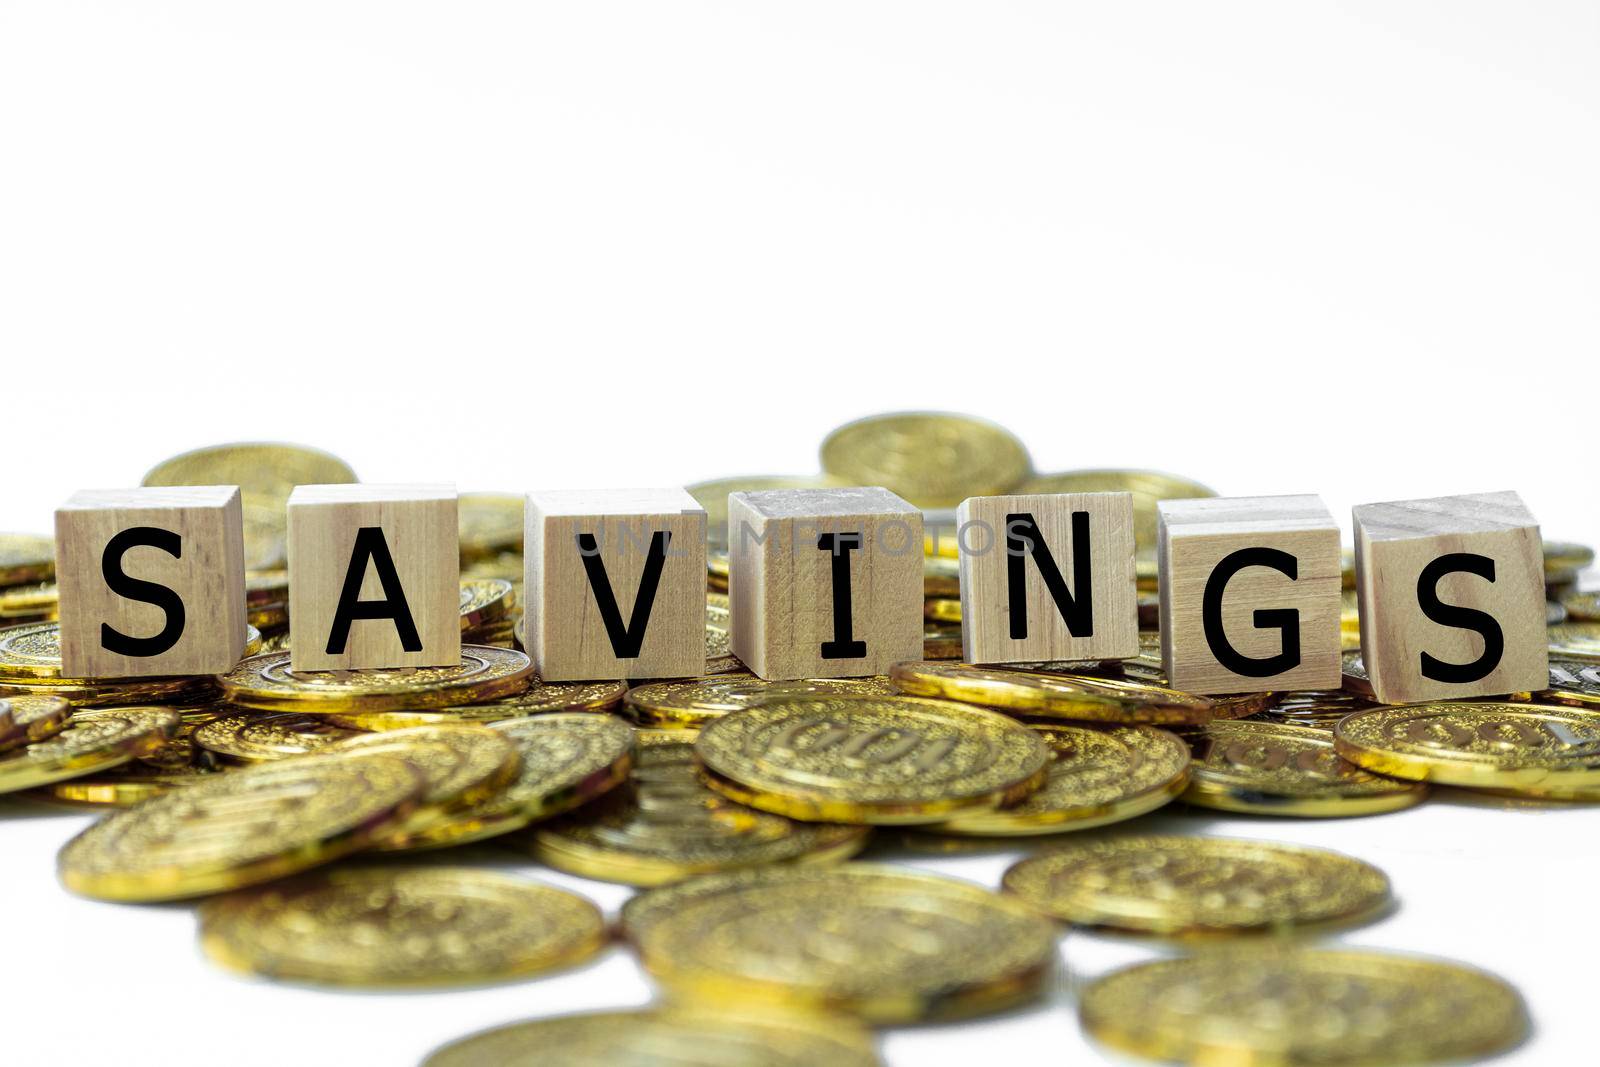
[928,723,1189,837]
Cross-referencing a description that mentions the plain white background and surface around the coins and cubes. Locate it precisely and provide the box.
[0,0,1600,1065]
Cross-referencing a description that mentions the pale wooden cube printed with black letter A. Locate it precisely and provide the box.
[288,485,461,670]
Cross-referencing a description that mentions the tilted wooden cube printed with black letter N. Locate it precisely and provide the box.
[955,493,1139,664]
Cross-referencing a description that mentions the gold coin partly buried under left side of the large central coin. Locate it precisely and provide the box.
[528,729,867,886]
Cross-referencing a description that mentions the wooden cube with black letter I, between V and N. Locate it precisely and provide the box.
[728,488,922,680]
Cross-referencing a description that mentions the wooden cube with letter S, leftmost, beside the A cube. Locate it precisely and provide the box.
[56,485,245,678]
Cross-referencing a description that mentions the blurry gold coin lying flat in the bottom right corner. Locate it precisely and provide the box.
[1078,945,1528,1067]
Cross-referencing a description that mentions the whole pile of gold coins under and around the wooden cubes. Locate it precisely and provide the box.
[0,413,1600,1067]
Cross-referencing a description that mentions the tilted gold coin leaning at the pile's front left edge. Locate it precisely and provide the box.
[56,753,422,901]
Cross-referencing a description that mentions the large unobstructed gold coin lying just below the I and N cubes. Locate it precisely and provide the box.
[694,696,1050,825]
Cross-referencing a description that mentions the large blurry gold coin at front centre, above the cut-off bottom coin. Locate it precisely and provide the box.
[622,864,1056,1022]
